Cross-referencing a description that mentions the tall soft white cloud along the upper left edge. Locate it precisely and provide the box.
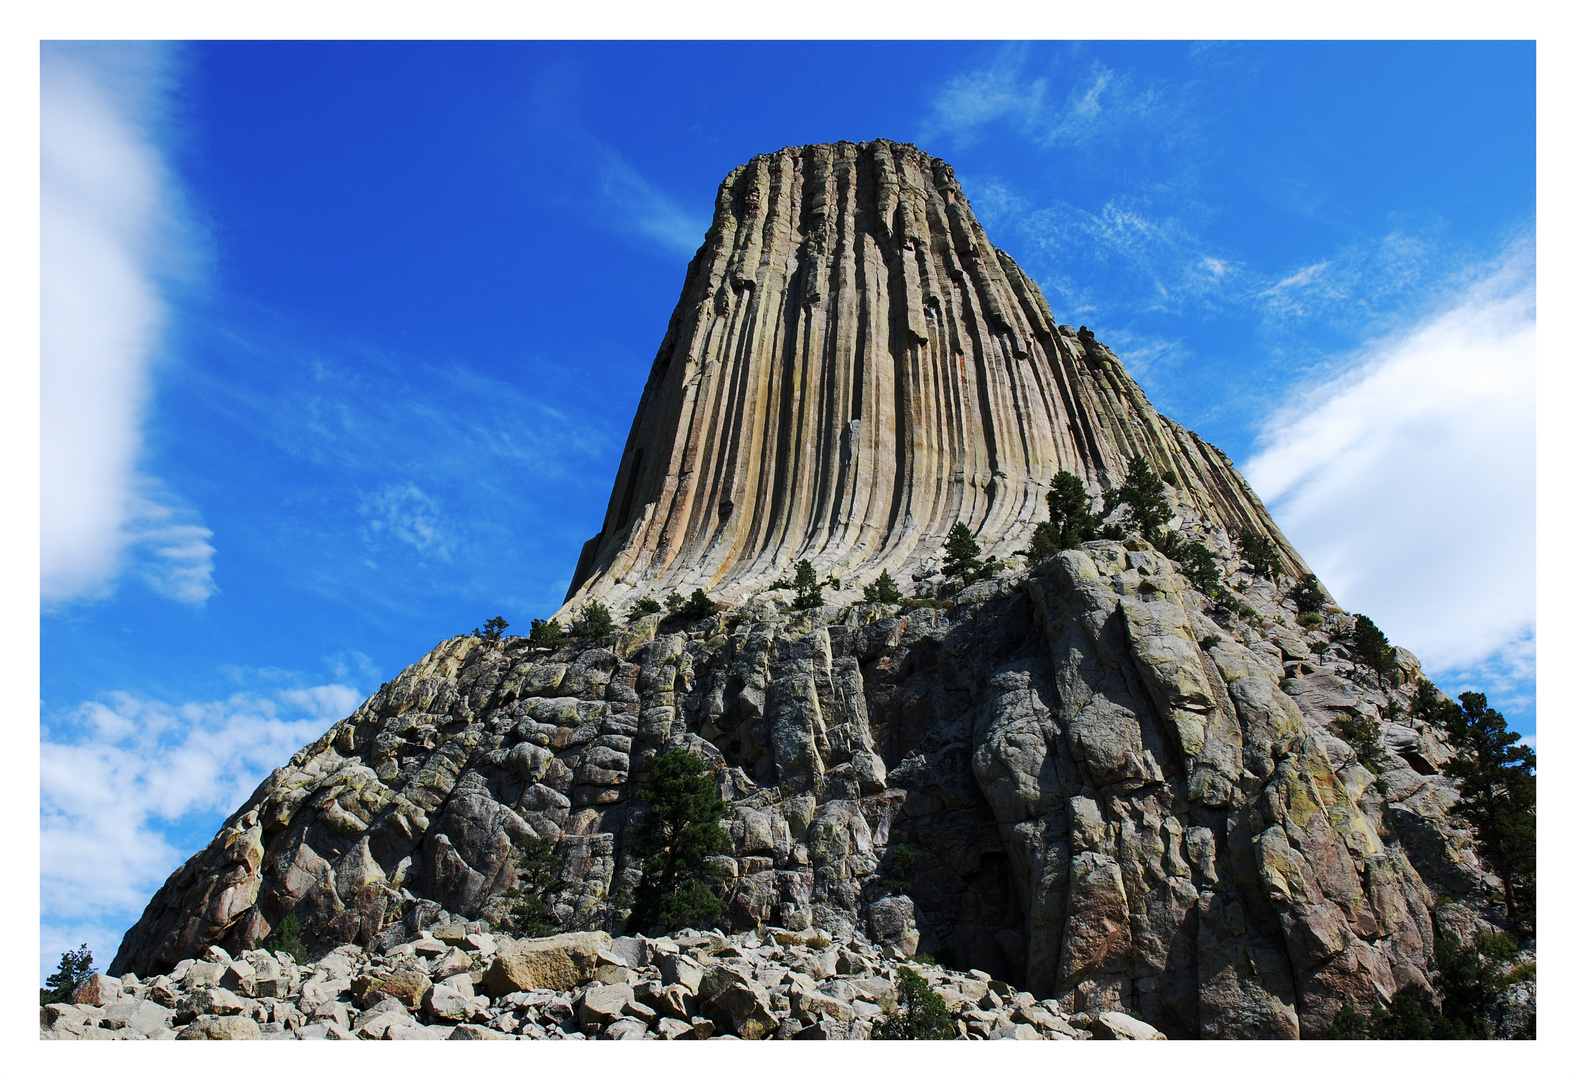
[39,43,213,605]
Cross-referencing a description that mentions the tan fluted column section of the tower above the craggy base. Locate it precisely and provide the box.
[566,140,1302,610]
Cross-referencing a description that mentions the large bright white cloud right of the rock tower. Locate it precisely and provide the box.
[1243,241,1537,681]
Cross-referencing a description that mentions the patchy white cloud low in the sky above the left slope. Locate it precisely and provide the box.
[39,683,362,970]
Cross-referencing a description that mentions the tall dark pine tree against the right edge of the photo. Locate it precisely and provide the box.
[1444,691,1538,927]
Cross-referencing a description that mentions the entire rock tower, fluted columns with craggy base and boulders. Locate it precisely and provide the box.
[101,140,1525,1037]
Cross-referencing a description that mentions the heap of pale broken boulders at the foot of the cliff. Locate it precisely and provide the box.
[39,922,1165,1041]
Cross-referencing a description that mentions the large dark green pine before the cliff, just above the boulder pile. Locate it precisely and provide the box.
[629,750,731,930]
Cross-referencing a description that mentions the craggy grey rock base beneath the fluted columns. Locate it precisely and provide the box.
[110,541,1494,1037]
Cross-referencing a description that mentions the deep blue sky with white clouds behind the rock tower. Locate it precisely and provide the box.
[41,43,1535,968]
